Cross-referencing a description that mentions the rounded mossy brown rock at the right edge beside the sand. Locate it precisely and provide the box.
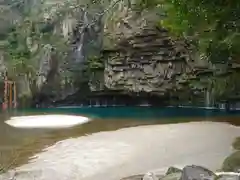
[222,151,240,171]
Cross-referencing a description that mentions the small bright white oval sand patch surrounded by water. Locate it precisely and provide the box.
[5,115,90,128]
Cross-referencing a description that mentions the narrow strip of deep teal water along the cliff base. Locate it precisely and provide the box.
[14,107,240,119]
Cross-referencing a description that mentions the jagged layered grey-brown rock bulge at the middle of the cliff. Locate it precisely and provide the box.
[104,28,194,96]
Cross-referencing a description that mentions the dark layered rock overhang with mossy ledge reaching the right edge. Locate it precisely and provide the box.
[86,26,239,107]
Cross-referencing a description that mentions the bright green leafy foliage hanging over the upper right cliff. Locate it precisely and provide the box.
[141,0,240,100]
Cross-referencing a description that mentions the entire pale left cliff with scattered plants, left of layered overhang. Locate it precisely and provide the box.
[0,0,103,107]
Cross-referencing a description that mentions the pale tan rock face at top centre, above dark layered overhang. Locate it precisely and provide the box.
[103,0,161,48]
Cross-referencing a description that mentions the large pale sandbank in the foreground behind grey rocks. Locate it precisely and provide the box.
[0,122,240,180]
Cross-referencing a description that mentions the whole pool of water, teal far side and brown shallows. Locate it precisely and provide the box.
[0,107,240,179]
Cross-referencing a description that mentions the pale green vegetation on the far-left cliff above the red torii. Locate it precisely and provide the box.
[0,1,66,100]
